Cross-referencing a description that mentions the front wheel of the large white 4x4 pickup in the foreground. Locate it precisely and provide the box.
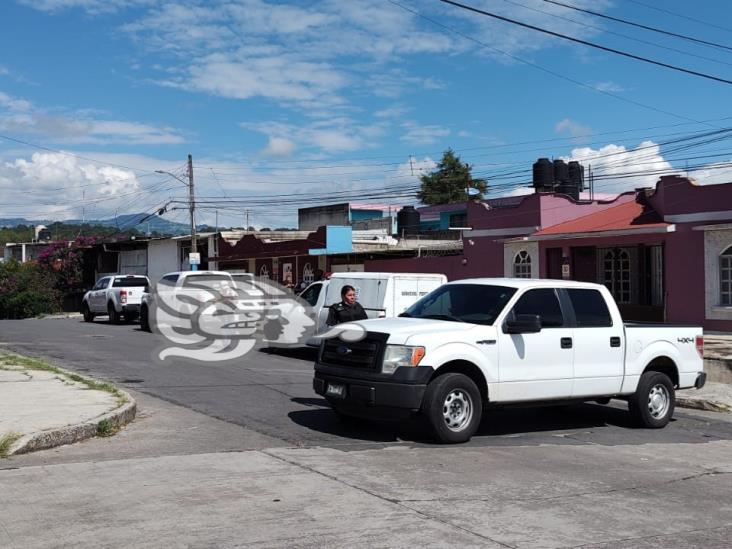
[422,373,483,444]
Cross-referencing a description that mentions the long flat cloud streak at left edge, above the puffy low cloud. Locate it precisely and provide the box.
[0,88,185,145]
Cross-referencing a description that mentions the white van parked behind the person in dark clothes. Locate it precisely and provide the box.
[300,273,447,346]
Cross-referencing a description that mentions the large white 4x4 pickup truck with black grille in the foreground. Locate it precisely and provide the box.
[313,278,706,443]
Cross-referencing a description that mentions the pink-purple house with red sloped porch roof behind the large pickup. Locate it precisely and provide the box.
[366,176,732,331]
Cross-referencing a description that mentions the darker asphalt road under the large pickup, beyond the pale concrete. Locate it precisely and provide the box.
[0,319,732,449]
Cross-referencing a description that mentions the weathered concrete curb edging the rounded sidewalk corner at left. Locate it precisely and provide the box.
[7,388,137,456]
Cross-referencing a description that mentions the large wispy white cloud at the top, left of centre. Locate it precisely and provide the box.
[122,0,455,109]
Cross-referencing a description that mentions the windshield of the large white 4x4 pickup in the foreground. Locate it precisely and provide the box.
[399,284,516,325]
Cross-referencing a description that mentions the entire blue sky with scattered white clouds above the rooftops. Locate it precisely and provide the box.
[0,0,732,226]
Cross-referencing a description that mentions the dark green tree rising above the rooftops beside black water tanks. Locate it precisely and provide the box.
[417,149,488,206]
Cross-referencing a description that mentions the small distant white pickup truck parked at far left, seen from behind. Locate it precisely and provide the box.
[81,275,150,324]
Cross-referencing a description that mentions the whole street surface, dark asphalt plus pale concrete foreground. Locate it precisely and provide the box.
[0,319,732,549]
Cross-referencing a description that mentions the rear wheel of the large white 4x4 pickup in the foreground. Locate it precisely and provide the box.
[628,372,676,429]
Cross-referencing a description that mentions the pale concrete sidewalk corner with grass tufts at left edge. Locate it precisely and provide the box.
[0,354,136,457]
